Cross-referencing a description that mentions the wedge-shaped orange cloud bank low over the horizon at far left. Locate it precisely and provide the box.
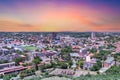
[0,21,37,32]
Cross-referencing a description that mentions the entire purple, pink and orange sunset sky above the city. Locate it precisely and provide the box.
[0,0,120,32]
